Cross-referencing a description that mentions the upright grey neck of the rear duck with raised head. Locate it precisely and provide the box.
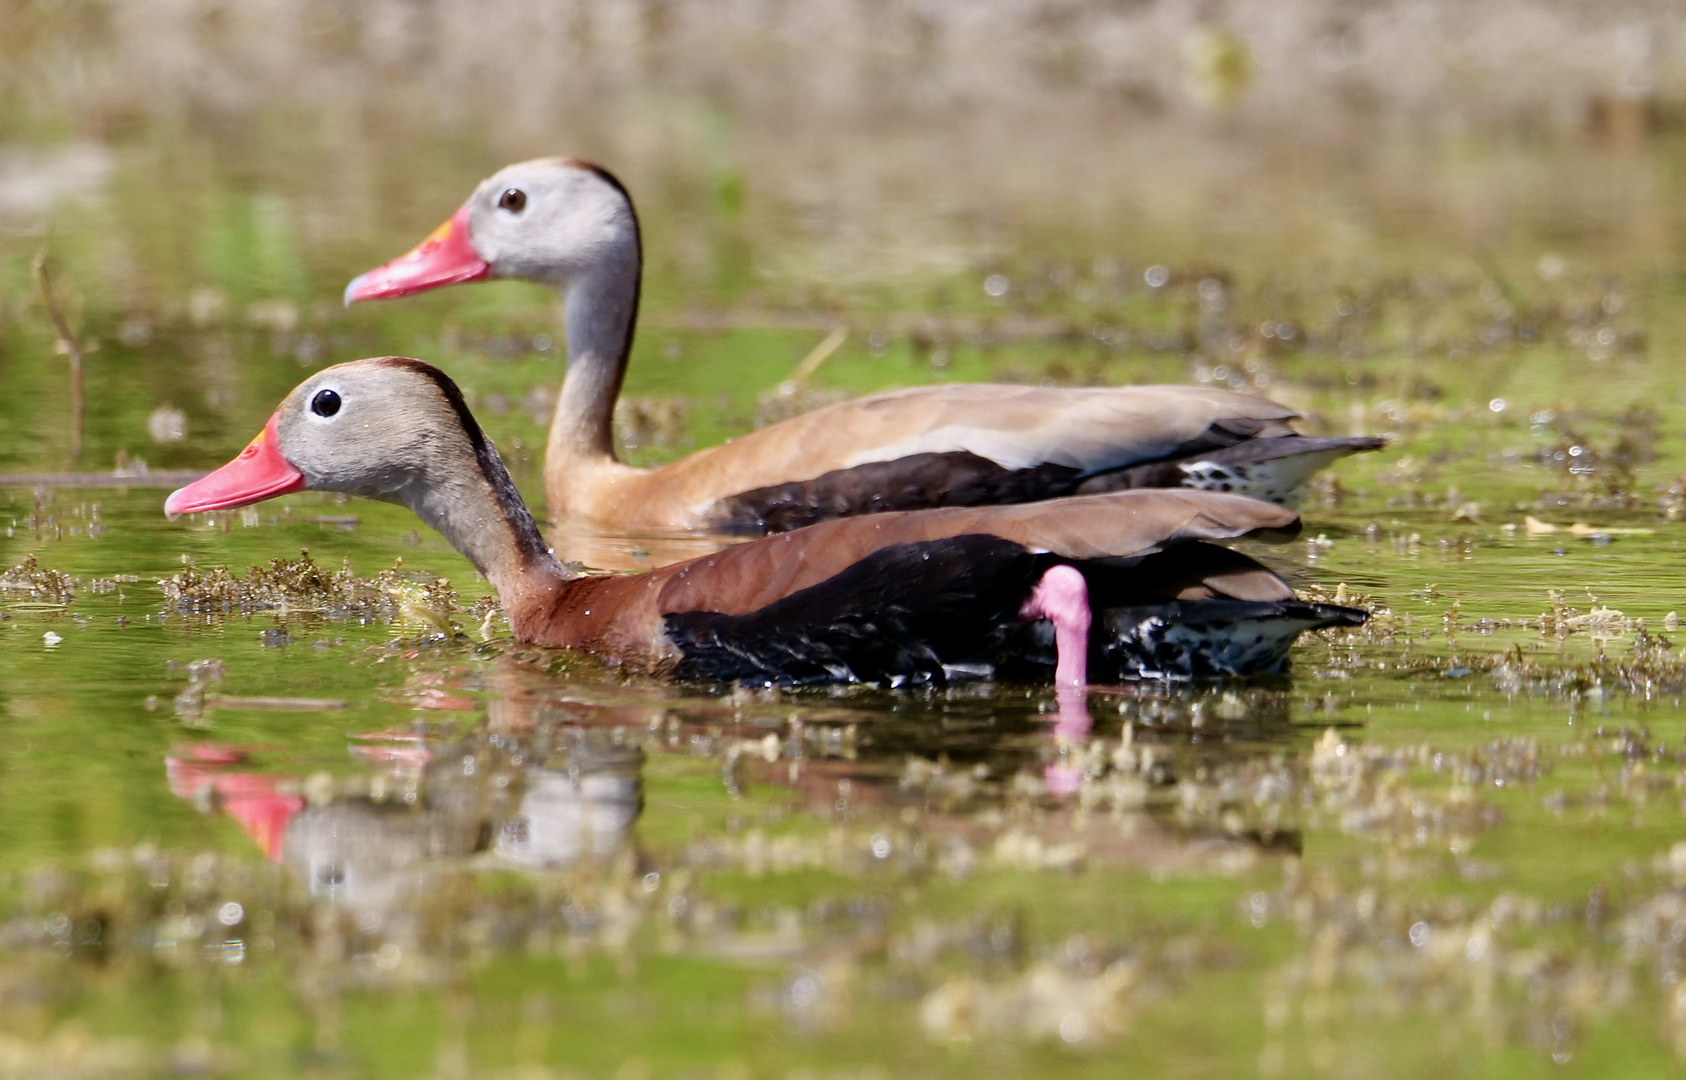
[545,226,642,462]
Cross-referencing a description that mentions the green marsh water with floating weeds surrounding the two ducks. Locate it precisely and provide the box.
[0,2,1686,1080]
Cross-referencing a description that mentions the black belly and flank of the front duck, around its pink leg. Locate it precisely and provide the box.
[664,536,1366,686]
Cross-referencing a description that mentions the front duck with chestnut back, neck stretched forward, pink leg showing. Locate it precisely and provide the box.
[164,357,1364,686]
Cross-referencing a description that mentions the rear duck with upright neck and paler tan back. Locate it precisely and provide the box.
[346,158,1383,532]
